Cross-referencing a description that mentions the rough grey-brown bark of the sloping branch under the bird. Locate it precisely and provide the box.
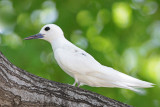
[0,52,130,107]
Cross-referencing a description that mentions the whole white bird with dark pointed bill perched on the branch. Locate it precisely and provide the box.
[25,24,154,91]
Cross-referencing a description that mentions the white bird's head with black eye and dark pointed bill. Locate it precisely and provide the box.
[24,24,64,42]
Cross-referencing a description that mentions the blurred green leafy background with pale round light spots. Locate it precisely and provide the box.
[0,0,160,107]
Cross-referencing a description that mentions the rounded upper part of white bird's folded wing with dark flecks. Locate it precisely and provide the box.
[54,46,101,75]
